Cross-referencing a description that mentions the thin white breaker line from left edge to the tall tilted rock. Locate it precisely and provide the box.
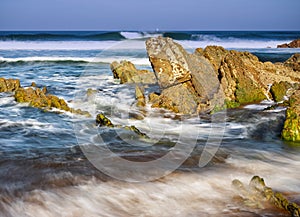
[0,56,150,66]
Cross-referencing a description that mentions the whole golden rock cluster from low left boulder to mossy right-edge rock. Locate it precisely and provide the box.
[111,37,300,142]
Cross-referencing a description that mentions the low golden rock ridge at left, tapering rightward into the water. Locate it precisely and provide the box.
[14,87,90,116]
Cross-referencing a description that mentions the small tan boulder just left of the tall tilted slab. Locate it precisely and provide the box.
[110,61,157,84]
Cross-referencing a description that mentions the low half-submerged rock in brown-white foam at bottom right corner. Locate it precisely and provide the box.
[232,176,300,217]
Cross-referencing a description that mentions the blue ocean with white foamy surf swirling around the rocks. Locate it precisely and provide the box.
[0,31,300,217]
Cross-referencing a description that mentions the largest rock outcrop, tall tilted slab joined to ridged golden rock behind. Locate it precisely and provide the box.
[146,37,300,114]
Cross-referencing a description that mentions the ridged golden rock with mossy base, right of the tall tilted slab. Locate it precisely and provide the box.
[202,46,300,105]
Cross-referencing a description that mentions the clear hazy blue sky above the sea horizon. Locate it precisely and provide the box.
[0,0,300,30]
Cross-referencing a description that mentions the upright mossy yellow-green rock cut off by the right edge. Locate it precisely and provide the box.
[281,90,300,142]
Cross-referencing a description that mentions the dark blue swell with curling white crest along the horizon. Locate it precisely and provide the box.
[0,31,300,41]
